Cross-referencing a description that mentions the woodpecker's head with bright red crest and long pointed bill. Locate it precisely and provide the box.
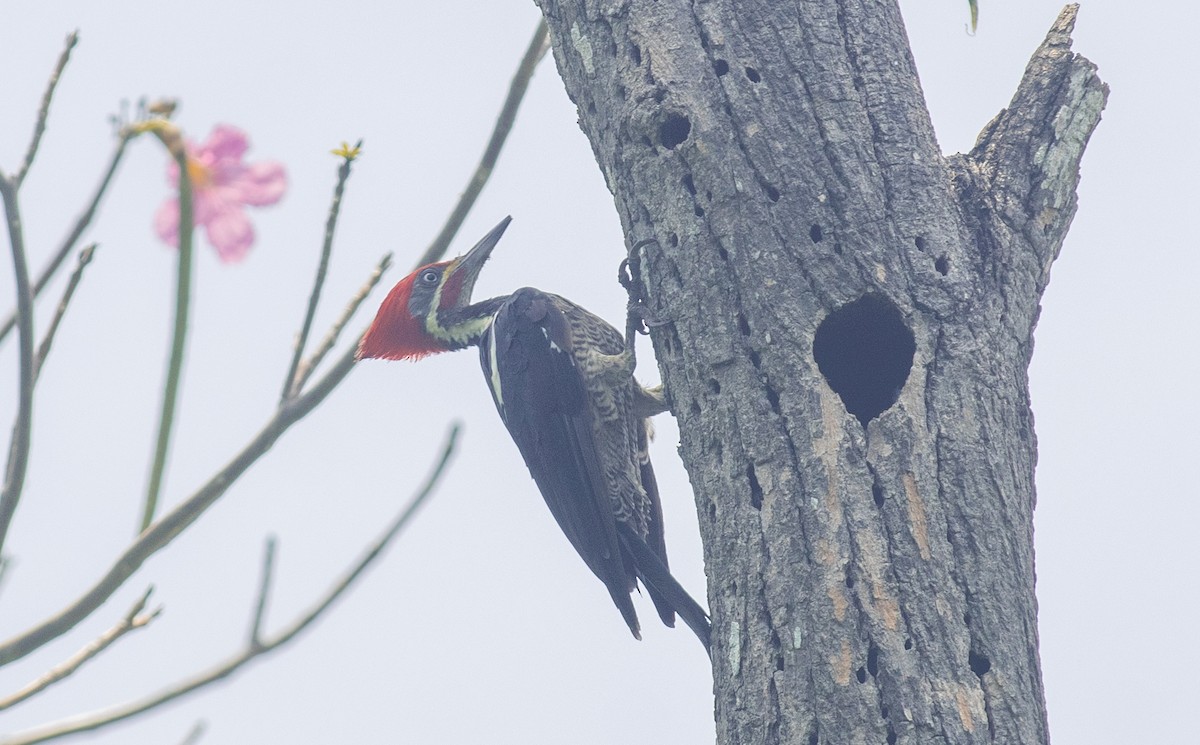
[355,217,511,360]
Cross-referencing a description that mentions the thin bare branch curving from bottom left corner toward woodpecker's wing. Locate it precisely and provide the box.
[0,422,460,745]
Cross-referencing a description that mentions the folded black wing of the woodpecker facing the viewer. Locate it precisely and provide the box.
[480,288,641,638]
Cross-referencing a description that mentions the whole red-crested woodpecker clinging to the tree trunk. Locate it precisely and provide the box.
[358,217,710,650]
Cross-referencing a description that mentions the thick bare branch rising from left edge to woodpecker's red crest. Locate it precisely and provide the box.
[0,256,384,666]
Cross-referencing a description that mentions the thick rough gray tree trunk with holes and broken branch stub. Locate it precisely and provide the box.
[538,0,1108,744]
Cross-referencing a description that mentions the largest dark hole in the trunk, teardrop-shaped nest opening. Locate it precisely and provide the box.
[812,294,917,427]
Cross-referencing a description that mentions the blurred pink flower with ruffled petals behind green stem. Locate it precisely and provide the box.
[154,125,288,264]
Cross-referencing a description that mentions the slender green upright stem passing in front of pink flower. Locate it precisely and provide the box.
[138,146,192,533]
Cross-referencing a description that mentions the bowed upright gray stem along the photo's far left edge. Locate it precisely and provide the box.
[0,179,34,554]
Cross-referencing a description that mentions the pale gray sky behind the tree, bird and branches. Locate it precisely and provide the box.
[0,0,1200,745]
